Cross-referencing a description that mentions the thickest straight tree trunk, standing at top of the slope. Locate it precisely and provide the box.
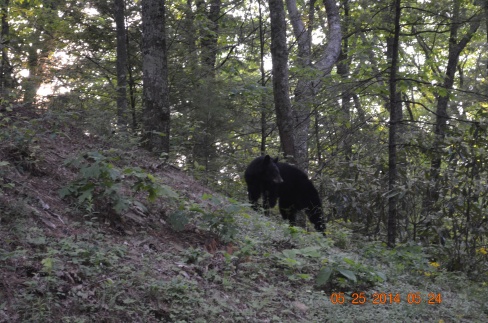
[142,0,170,155]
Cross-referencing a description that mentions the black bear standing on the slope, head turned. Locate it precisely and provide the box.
[244,155,325,232]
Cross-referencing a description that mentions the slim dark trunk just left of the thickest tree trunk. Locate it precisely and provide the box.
[114,0,128,131]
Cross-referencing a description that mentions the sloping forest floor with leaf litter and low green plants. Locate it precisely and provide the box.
[0,105,488,322]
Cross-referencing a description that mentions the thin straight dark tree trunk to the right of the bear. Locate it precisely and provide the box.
[388,0,402,248]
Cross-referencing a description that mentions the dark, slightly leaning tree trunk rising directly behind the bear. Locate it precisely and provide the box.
[268,0,296,163]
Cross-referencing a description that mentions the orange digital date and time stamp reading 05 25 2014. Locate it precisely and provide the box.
[330,292,442,305]
